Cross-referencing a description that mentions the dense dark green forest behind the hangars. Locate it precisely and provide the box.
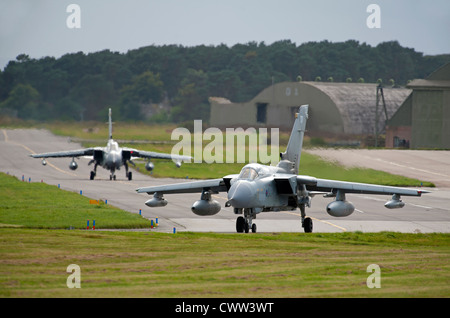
[0,40,450,123]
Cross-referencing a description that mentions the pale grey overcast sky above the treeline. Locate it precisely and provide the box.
[0,0,450,69]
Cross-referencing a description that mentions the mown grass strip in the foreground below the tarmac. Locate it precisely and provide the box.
[0,228,450,298]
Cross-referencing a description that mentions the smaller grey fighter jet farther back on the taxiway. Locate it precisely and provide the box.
[30,108,192,180]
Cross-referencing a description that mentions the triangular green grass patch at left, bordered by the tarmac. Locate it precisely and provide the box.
[0,173,150,229]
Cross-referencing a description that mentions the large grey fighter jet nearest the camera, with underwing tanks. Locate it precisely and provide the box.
[136,105,428,233]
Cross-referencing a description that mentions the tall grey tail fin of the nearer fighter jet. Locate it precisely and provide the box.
[279,105,309,174]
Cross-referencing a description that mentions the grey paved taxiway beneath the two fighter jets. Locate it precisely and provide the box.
[0,129,450,233]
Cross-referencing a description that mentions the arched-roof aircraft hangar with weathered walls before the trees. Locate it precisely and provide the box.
[209,81,411,136]
